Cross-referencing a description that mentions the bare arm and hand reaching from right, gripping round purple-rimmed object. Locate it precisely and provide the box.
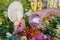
[29,8,60,23]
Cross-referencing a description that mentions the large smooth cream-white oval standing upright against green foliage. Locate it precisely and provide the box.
[8,1,23,22]
